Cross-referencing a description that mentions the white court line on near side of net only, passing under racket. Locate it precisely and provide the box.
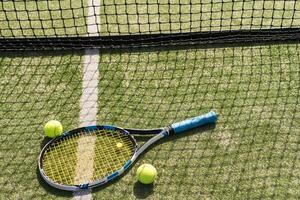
[73,50,99,200]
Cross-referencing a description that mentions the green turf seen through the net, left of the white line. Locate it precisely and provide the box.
[0,0,87,38]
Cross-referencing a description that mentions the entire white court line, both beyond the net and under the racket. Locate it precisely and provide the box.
[73,0,100,200]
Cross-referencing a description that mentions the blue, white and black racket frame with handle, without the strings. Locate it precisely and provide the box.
[38,111,217,191]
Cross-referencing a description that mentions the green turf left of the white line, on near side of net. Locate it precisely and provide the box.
[0,54,82,199]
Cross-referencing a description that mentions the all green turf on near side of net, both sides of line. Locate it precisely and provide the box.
[0,44,300,199]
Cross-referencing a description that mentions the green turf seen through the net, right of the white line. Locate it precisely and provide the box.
[100,0,300,35]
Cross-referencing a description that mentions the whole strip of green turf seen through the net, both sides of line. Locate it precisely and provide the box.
[0,0,300,38]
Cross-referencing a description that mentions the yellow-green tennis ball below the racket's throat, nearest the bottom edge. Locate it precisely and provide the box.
[136,164,157,184]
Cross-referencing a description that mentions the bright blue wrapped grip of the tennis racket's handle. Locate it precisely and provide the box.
[171,111,218,133]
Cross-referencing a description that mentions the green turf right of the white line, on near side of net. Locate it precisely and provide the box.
[93,44,300,199]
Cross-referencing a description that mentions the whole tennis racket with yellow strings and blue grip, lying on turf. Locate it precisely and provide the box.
[38,111,217,191]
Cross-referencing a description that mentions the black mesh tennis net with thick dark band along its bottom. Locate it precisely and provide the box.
[0,0,300,49]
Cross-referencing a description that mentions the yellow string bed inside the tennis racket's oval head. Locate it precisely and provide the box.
[43,130,135,185]
